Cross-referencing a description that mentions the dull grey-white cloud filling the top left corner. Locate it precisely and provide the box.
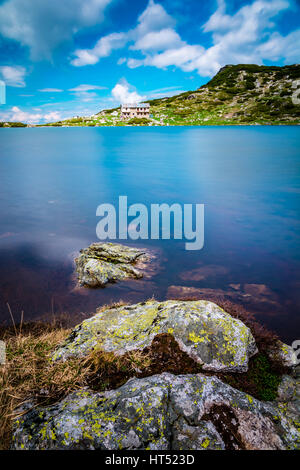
[0,0,112,59]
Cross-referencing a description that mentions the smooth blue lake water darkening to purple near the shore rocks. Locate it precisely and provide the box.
[0,126,300,342]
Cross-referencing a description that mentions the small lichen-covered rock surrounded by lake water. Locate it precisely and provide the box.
[75,243,147,287]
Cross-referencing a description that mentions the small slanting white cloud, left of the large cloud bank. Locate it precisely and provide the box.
[71,33,127,67]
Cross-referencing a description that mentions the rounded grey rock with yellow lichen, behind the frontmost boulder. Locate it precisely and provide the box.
[53,300,257,372]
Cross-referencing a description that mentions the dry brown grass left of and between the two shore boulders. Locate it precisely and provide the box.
[0,314,149,450]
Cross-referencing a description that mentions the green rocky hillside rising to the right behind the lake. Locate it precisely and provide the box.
[41,64,300,126]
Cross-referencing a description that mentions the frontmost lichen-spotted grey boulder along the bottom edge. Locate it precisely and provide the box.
[12,373,300,450]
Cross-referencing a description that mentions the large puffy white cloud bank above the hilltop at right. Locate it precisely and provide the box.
[123,0,300,76]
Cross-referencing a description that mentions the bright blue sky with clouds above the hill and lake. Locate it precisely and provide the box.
[0,0,300,124]
